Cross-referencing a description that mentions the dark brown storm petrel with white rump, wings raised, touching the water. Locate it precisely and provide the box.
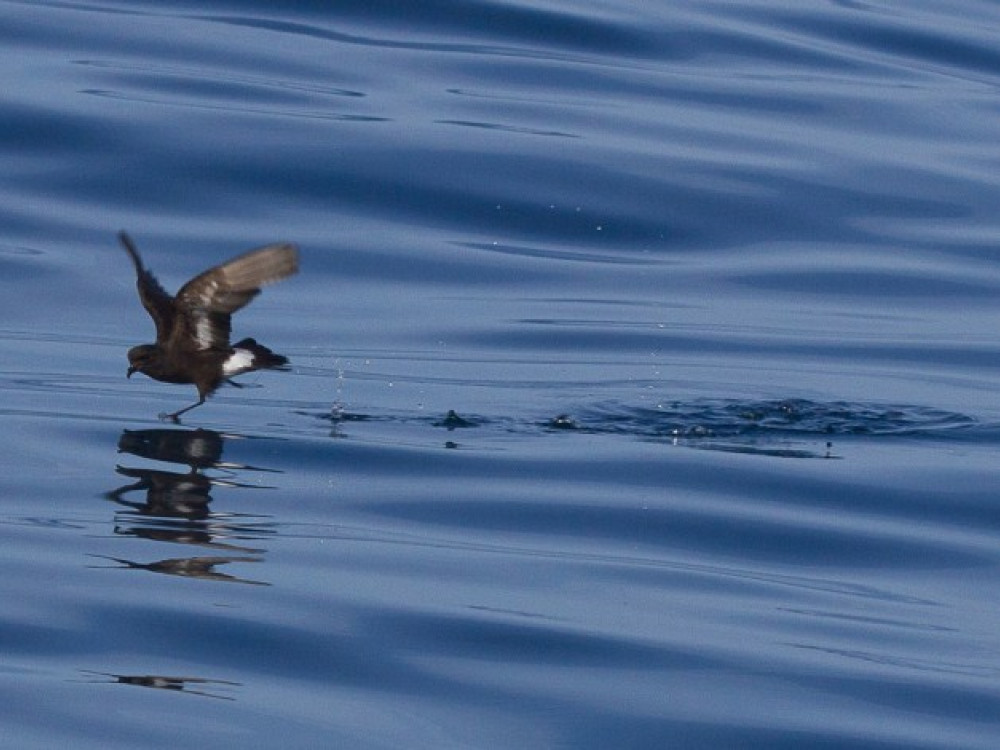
[118,232,299,422]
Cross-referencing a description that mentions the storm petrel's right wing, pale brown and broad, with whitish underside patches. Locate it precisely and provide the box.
[175,244,299,350]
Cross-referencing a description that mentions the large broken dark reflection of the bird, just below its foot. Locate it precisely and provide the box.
[97,429,274,584]
